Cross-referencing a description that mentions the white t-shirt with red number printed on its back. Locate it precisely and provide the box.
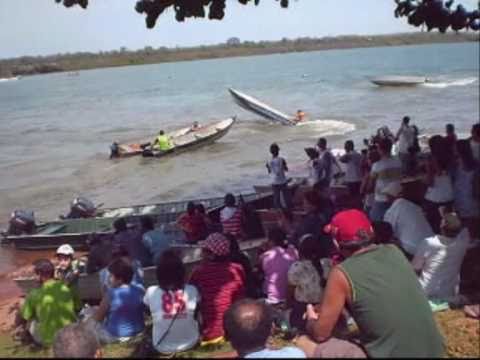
[143,285,200,353]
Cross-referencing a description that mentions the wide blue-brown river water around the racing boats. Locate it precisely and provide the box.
[0,43,479,271]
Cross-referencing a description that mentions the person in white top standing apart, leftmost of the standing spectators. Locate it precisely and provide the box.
[266,143,292,209]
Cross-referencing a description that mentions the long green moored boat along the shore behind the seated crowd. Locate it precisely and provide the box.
[1,193,260,250]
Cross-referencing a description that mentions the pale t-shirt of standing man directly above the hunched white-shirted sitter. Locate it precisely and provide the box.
[371,157,402,202]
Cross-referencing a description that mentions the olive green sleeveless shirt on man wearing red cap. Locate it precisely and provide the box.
[339,245,444,358]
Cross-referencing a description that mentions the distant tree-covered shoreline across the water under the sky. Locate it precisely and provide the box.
[0,33,479,77]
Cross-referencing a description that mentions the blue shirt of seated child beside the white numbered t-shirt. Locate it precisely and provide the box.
[105,285,145,338]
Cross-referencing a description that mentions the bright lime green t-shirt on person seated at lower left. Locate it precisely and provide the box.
[20,279,76,345]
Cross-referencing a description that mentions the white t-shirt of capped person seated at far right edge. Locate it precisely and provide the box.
[412,229,470,300]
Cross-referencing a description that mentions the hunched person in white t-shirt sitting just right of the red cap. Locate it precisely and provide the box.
[384,178,434,260]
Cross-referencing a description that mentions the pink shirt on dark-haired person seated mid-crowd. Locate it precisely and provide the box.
[260,245,298,304]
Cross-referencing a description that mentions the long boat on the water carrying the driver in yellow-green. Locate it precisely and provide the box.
[110,117,236,158]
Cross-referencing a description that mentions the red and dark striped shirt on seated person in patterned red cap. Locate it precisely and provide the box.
[190,262,245,341]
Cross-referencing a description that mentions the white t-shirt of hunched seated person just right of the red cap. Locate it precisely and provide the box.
[383,198,434,255]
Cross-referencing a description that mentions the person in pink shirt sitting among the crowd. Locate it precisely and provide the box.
[259,227,298,305]
